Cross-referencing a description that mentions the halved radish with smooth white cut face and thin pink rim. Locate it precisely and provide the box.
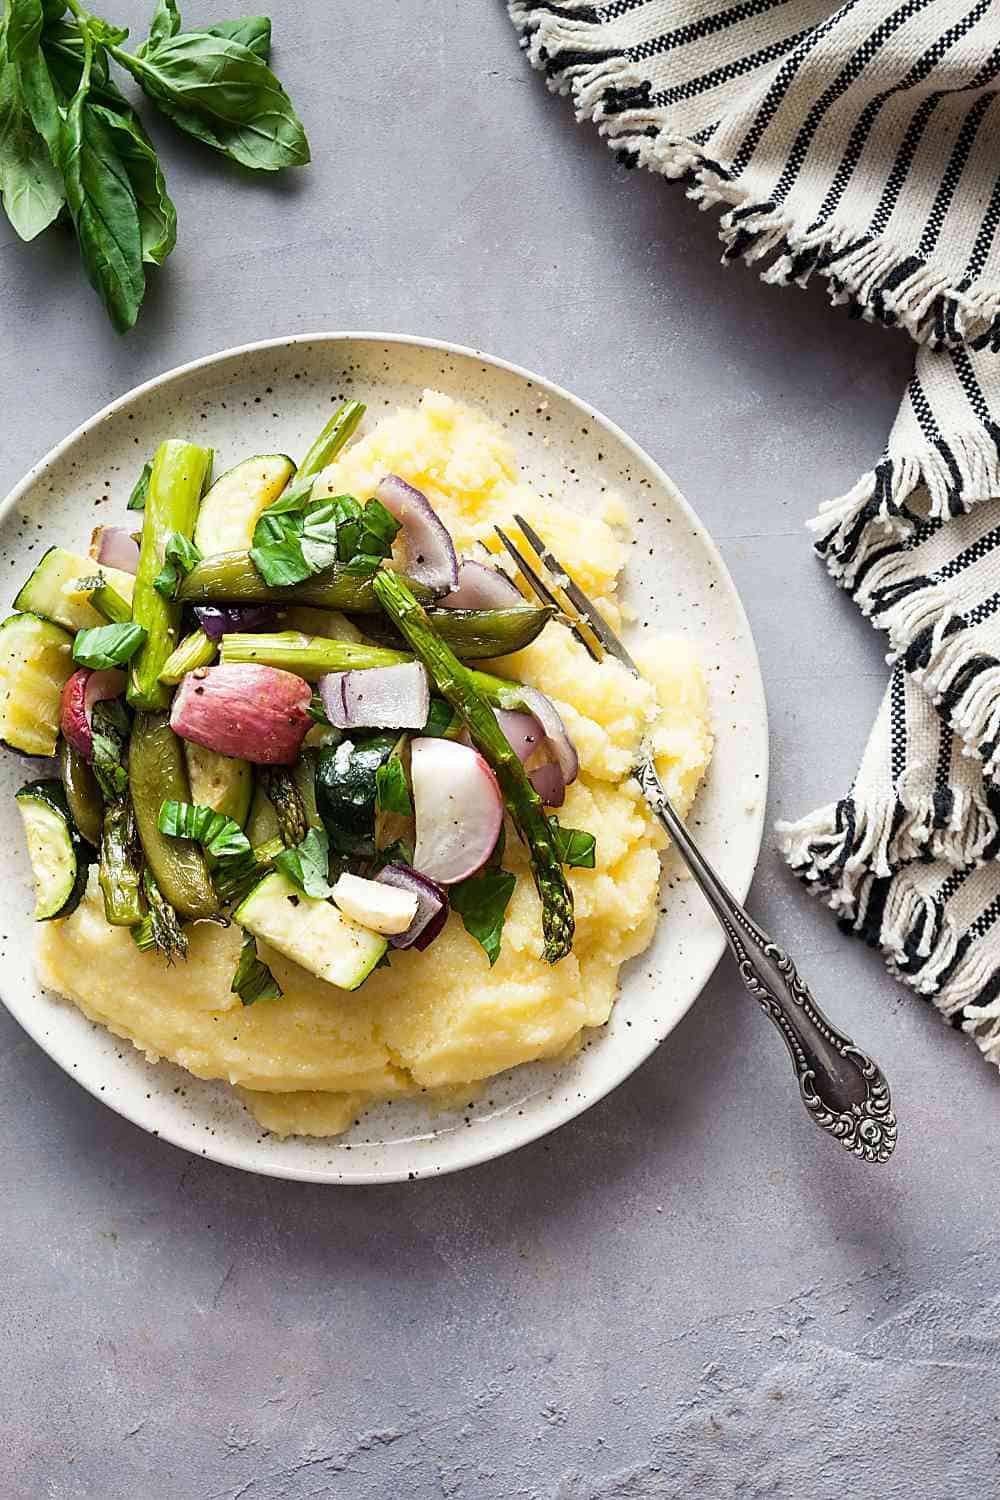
[409,738,504,885]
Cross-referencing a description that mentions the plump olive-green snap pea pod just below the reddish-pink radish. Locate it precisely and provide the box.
[129,714,219,918]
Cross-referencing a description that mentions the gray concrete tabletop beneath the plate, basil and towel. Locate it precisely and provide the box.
[0,0,1000,1500]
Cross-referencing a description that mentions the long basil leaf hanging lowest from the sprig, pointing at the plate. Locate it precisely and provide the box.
[57,68,145,333]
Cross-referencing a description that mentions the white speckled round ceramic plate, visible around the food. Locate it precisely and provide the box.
[0,333,768,1182]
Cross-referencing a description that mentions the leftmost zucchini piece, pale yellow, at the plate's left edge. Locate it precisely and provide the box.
[0,615,73,755]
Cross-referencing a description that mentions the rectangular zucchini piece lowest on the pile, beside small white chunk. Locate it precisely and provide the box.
[232,875,388,990]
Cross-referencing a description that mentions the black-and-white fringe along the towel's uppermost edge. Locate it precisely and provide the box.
[507,0,1000,350]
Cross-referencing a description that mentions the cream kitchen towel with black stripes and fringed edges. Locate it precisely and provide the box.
[510,0,1000,1065]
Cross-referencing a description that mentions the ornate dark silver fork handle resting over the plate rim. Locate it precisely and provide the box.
[636,761,897,1163]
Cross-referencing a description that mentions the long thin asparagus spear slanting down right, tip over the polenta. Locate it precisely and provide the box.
[373,570,574,963]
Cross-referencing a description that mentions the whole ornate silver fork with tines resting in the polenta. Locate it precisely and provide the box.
[496,515,897,1163]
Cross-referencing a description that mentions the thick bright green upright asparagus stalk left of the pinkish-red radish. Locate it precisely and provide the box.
[129,438,211,708]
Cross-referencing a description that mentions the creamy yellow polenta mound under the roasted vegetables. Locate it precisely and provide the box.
[39,392,712,1136]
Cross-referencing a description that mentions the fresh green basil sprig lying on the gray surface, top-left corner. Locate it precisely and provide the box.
[0,0,309,330]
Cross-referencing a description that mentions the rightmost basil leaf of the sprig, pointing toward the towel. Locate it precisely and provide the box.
[111,32,309,171]
